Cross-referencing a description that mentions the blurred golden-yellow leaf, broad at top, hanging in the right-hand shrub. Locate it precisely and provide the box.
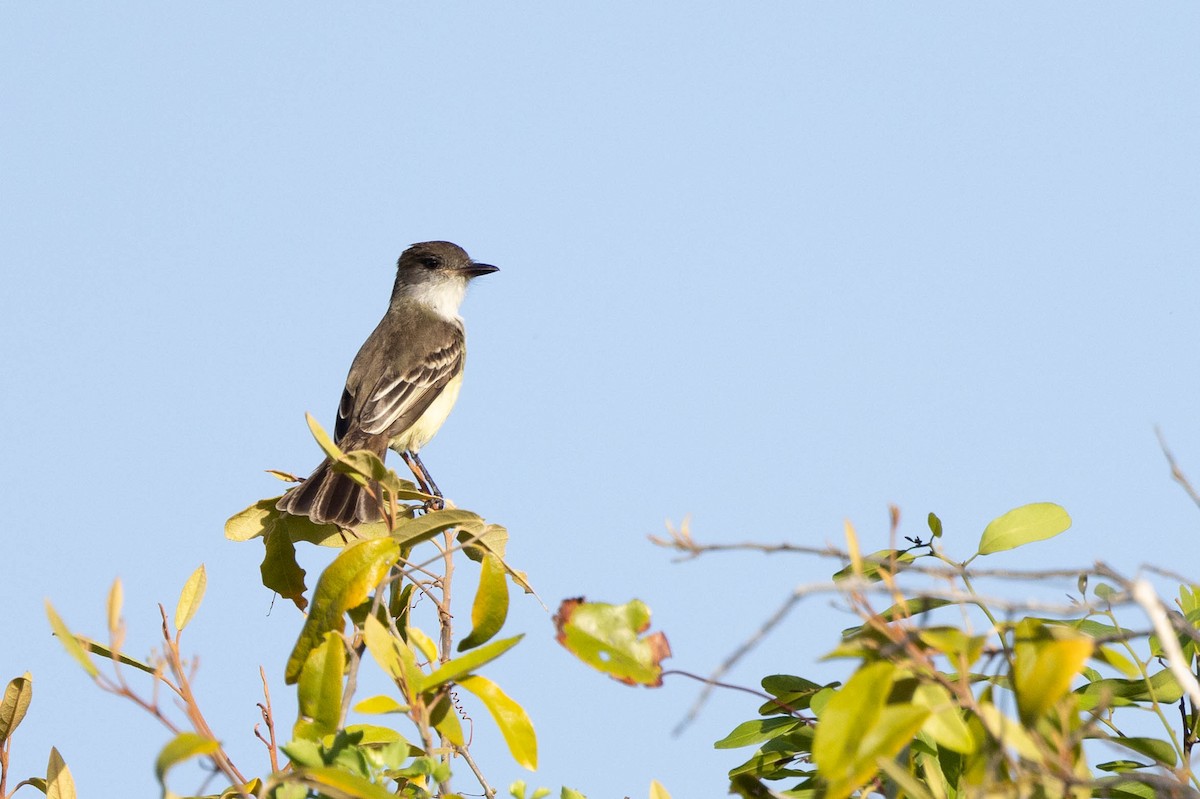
[1013,611,1094,723]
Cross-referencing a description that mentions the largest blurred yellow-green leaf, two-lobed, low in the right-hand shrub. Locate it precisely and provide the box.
[812,661,929,799]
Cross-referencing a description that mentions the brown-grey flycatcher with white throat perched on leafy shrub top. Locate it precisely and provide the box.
[276,241,498,528]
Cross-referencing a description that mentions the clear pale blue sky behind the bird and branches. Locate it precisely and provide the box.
[0,2,1200,797]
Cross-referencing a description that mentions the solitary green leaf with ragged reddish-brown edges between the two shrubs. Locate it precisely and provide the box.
[554,599,671,687]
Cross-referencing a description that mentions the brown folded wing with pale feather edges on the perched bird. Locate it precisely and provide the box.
[334,328,466,440]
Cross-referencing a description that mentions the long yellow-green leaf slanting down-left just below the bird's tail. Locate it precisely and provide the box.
[283,539,400,685]
